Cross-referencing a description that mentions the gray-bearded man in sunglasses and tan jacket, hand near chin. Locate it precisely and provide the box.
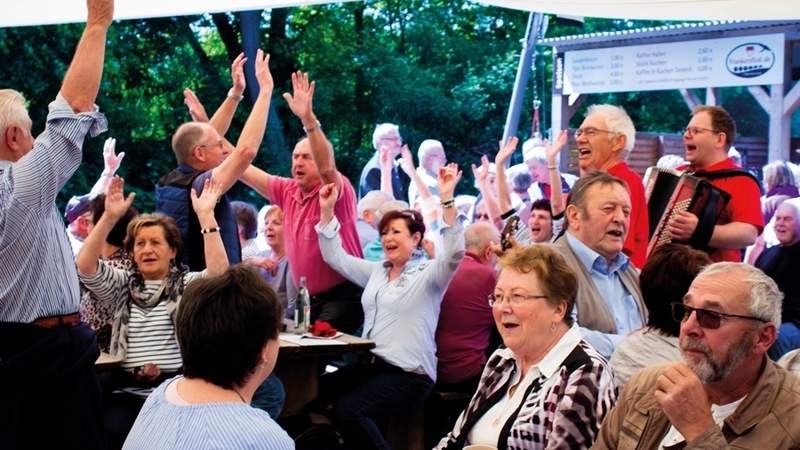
[592,262,800,450]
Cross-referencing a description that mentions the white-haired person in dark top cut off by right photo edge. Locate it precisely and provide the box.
[755,202,800,360]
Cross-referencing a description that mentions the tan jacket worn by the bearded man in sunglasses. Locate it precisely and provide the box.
[592,361,800,450]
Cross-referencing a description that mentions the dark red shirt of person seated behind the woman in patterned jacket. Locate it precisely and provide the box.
[436,253,495,384]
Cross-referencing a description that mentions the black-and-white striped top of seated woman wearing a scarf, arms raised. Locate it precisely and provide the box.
[80,261,205,371]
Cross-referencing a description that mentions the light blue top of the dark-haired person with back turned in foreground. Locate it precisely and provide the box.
[122,378,295,450]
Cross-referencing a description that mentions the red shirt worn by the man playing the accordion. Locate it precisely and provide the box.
[678,158,764,262]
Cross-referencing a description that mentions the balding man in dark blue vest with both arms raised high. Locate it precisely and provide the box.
[156,50,273,271]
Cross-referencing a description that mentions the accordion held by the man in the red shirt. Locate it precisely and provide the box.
[644,167,731,256]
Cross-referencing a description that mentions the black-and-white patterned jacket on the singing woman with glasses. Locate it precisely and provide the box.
[436,341,617,450]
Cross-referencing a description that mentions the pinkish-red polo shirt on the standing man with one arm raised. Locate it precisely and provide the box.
[267,174,363,295]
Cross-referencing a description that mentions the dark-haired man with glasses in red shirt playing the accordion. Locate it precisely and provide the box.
[667,106,764,262]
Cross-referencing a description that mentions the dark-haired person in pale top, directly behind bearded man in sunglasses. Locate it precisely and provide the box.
[611,244,711,388]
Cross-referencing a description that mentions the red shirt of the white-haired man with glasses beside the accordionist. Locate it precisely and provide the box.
[608,161,650,269]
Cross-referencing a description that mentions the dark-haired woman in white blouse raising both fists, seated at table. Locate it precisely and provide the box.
[317,164,464,449]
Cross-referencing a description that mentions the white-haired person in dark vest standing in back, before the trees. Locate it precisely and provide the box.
[358,123,411,201]
